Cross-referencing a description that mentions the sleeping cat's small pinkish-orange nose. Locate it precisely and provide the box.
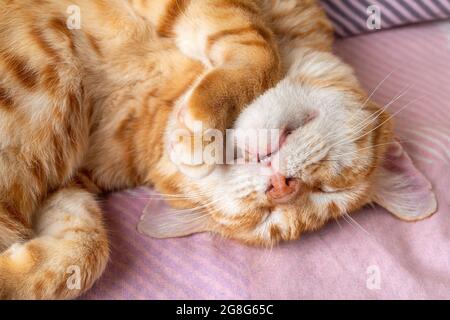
[267,173,300,203]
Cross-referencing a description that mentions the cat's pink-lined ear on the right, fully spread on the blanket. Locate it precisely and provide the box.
[372,141,437,221]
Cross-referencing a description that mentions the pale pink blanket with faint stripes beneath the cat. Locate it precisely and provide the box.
[84,22,450,299]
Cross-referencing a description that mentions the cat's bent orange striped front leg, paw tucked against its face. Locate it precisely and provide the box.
[132,0,281,176]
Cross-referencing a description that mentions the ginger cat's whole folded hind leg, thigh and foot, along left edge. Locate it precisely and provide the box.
[0,1,107,298]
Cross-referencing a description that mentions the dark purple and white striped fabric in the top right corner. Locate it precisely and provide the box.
[321,0,450,37]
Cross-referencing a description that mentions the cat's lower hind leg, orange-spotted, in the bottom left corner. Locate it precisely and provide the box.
[0,187,109,299]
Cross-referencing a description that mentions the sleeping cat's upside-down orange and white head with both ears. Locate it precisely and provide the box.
[144,53,436,245]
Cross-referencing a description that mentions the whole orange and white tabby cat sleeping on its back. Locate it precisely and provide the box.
[0,0,436,299]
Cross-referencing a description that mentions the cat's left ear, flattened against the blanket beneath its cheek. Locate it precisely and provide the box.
[138,206,209,239]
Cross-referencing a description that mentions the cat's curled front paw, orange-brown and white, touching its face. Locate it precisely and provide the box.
[170,69,241,178]
